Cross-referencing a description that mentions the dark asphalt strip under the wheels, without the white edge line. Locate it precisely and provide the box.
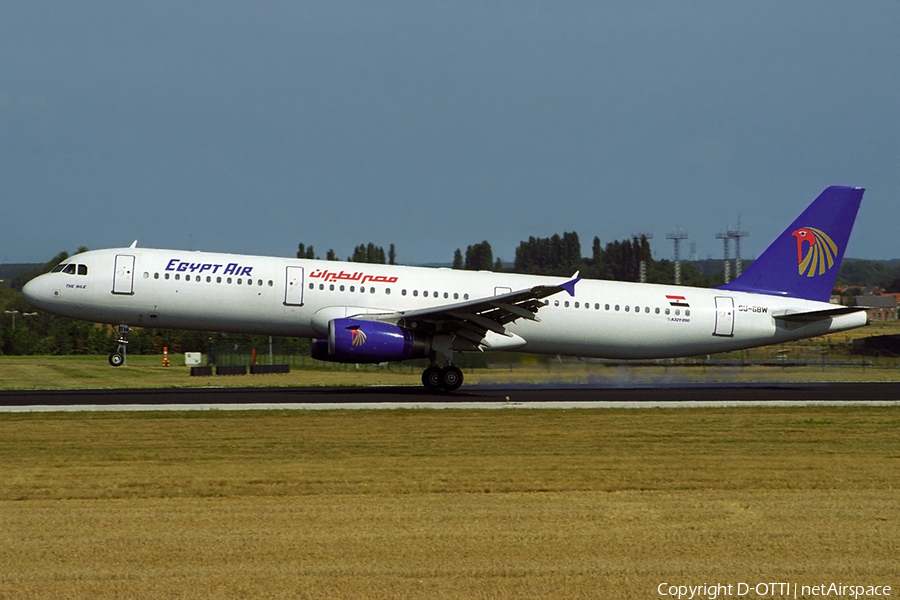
[0,383,900,407]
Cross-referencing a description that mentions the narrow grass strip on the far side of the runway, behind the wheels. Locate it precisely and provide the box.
[0,356,900,390]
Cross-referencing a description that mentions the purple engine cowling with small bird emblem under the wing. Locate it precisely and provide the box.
[309,319,431,363]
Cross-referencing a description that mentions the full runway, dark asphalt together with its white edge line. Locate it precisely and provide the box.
[0,383,900,412]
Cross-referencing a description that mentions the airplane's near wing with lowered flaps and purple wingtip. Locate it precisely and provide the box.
[355,273,581,345]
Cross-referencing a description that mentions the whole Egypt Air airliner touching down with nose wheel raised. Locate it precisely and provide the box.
[22,186,868,392]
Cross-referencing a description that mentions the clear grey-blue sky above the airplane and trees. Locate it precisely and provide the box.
[0,0,900,264]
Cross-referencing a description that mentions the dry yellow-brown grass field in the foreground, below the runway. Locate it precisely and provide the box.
[0,408,900,599]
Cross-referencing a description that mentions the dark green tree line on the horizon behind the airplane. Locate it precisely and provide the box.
[0,232,900,354]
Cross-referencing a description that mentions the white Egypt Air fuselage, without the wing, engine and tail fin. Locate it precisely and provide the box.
[24,248,866,359]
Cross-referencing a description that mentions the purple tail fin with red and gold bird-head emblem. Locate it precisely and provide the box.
[719,186,865,302]
